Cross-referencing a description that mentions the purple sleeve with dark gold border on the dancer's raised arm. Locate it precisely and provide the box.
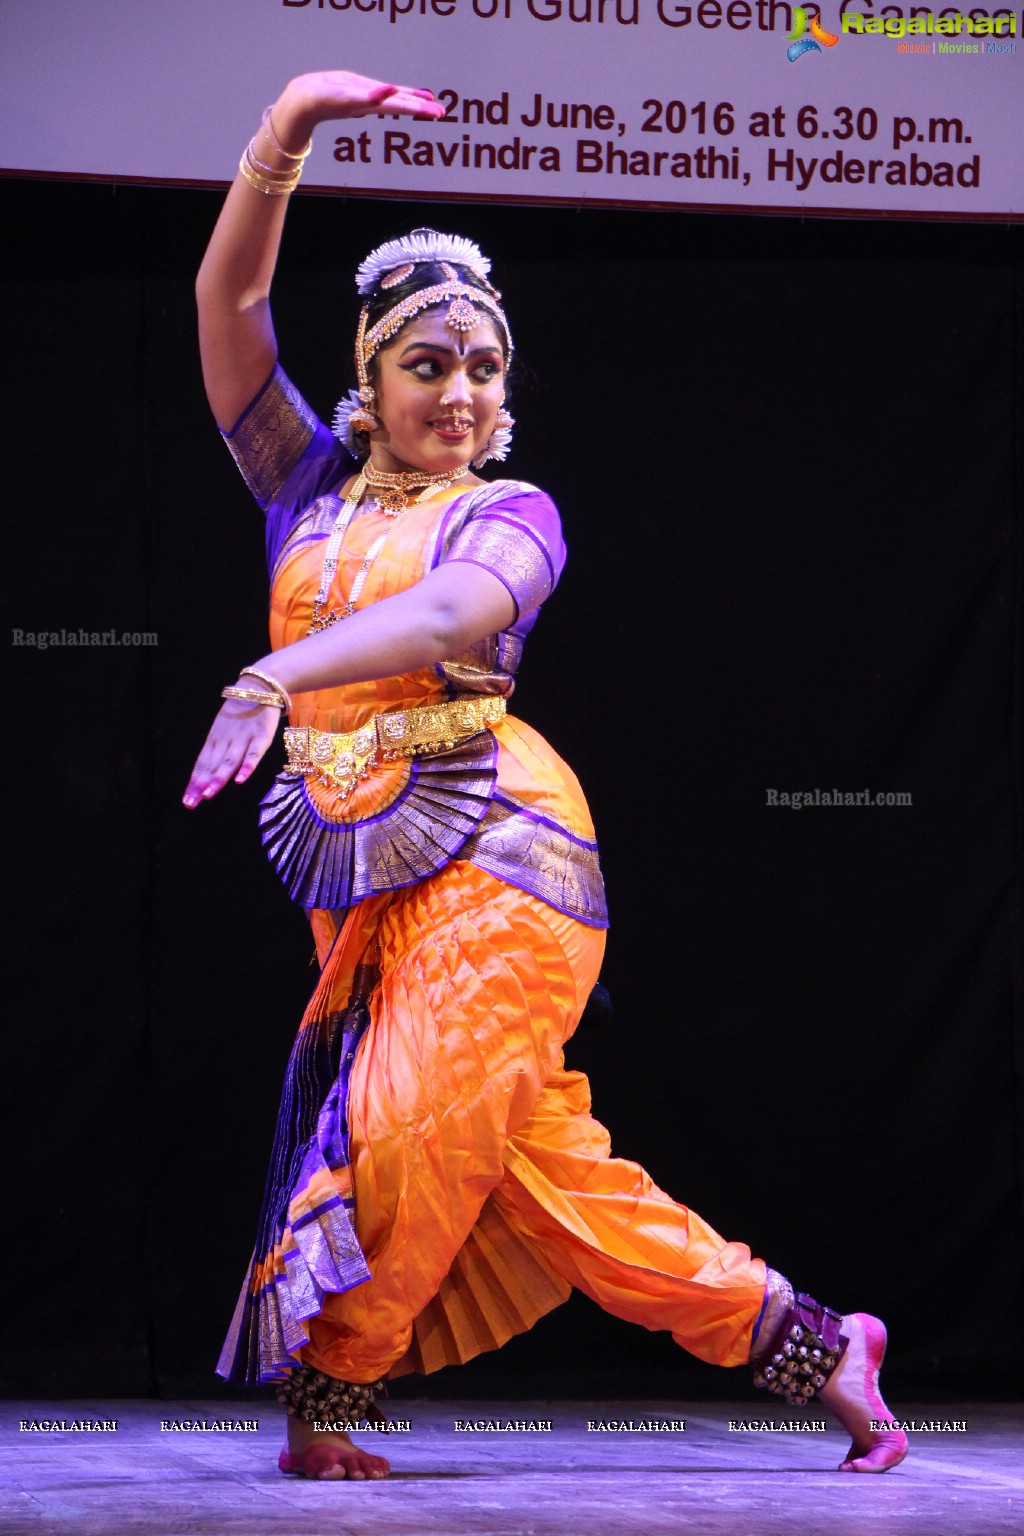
[223,364,356,568]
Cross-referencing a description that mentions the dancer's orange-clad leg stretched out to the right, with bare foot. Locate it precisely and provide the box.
[493,1071,907,1471]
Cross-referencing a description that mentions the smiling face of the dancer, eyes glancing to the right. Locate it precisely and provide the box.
[370,304,505,472]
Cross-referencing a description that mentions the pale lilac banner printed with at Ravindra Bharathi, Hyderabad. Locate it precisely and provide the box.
[0,0,1024,220]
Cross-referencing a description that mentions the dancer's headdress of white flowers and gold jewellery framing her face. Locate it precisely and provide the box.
[332,229,514,468]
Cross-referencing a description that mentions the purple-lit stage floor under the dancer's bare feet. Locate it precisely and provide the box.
[0,1399,1024,1536]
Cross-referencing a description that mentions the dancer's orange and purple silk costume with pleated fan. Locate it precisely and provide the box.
[218,369,791,1384]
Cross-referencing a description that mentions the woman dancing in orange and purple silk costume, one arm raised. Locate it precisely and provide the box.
[184,71,906,1478]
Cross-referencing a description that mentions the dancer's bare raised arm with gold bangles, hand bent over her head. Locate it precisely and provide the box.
[195,69,444,432]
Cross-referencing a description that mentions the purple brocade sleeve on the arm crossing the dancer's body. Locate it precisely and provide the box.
[445,484,565,617]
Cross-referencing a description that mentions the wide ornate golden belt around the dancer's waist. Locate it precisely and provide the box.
[284,694,505,797]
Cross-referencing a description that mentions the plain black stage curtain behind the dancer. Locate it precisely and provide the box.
[0,181,1024,1398]
